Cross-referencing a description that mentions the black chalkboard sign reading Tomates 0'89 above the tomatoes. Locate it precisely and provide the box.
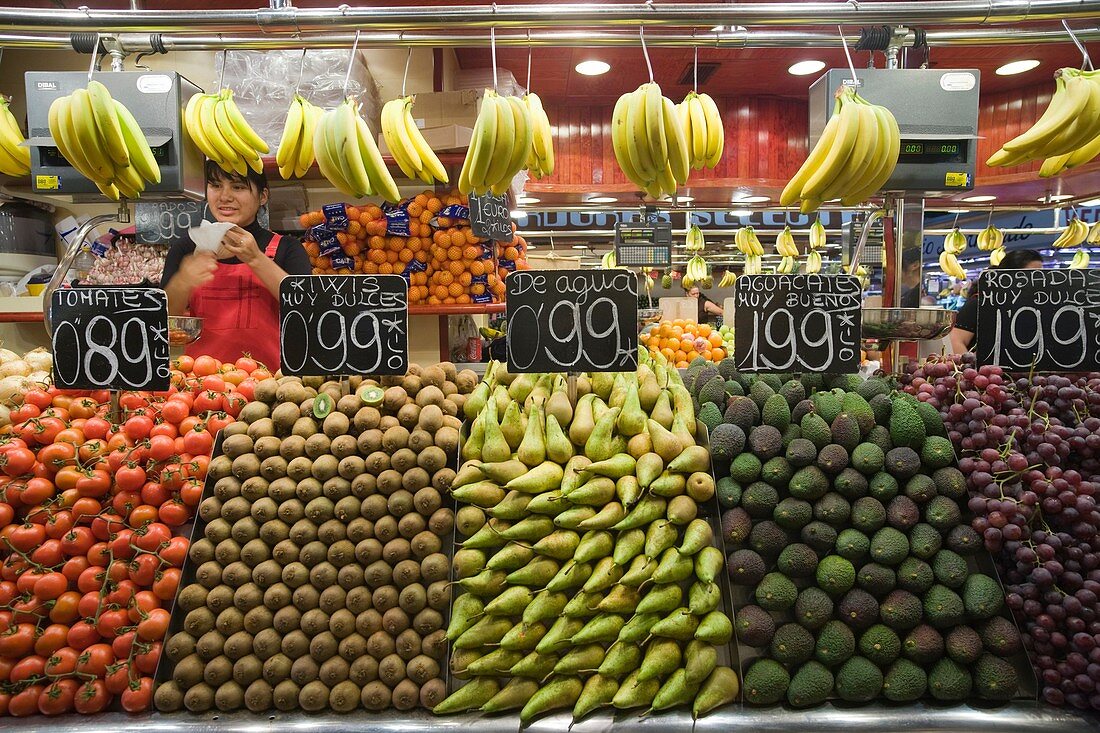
[50,287,172,392]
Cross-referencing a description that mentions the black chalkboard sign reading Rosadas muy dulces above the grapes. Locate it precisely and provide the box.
[975,270,1100,372]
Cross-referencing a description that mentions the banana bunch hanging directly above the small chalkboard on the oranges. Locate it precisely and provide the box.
[459,89,535,196]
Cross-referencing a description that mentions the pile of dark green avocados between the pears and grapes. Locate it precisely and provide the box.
[685,359,1021,708]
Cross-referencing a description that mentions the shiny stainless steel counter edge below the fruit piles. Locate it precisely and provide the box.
[0,702,1100,733]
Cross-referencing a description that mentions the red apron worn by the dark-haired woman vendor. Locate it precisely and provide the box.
[186,234,281,372]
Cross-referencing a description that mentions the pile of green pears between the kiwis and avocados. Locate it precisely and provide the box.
[435,352,739,724]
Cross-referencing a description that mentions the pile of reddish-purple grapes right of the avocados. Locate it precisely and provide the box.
[902,355,1100,710]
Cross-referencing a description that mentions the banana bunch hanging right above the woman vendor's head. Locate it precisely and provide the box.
[184,89,268,176]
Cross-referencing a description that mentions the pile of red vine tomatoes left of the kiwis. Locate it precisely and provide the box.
[0,357,264,716]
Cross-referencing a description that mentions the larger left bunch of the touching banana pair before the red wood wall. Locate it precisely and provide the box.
[612,81,691,198]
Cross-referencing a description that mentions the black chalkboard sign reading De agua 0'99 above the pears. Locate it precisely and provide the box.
[504,270,638,373]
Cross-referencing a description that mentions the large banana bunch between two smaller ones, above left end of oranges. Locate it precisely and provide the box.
[314,97,402,204]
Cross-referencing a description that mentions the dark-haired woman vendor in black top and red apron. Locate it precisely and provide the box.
[161,161,312,365]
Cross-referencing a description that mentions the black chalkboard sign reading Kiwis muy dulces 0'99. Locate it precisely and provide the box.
[278,275,409,376]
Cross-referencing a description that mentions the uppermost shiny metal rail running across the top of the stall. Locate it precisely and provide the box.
[0,0,1100,33]
